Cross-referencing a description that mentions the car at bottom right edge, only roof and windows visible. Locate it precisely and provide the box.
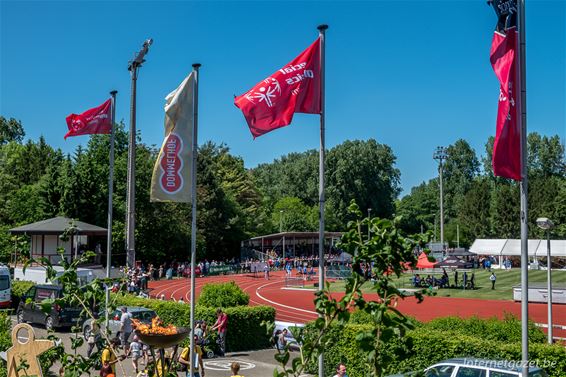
[388,358,547,377]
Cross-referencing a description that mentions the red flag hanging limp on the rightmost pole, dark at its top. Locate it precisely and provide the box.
[490,0,521,181]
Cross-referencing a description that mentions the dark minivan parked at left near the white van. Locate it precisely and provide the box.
[16,284,82,330]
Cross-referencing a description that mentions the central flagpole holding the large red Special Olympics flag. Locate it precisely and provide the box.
[317,25,328,377]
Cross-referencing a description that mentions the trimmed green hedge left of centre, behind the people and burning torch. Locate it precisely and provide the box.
[116,295,275,352]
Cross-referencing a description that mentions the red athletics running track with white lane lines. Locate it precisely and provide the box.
[149,271,566,338]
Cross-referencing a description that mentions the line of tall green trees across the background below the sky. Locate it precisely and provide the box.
[0,117,566,263]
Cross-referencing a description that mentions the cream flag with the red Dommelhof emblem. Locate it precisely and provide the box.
[150,72,195,202]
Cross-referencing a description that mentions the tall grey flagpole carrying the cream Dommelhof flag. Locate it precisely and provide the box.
[189,63,201,376]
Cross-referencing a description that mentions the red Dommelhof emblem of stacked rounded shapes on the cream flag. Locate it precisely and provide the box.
[159,133,184,194]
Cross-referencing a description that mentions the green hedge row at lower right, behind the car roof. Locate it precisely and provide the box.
[307,319,566,377]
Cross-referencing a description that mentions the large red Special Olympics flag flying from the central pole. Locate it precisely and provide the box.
[234,38,321,139]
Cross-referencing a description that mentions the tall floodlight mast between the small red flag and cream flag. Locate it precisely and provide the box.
[126,38,153,269]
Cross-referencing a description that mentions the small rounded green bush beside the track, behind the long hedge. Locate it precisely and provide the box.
[197,281,250,308]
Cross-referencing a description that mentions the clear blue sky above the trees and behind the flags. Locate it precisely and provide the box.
[0,0,566,197]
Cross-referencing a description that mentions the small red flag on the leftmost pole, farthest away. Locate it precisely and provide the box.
[65,99,112,139]
